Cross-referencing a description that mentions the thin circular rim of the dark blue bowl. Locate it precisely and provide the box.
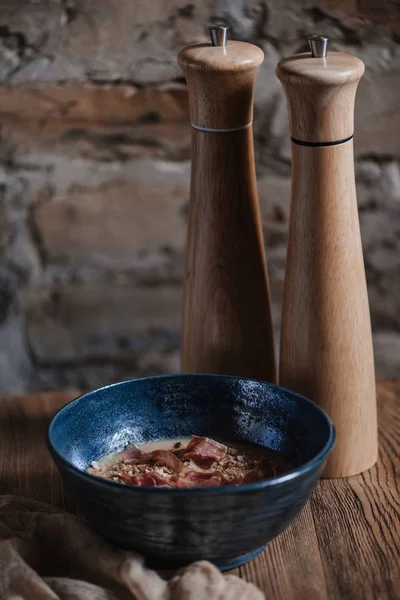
[46,373,336,496]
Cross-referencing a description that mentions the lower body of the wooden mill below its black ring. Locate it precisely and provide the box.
[279,141,378,477]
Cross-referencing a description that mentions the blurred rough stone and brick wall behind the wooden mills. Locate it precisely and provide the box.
[0,0,400,392]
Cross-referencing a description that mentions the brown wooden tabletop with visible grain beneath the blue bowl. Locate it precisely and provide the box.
[0,382,400,600]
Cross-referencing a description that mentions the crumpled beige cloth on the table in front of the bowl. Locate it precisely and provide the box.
[0,496,265,600]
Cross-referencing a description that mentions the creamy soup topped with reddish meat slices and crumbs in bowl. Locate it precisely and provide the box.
[87,436,293,488]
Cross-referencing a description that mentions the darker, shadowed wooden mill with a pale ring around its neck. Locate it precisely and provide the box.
[178,27,276,381]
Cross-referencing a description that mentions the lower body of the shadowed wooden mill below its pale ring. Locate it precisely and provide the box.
[181,128,276,382]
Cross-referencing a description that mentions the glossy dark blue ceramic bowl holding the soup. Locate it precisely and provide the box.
[48,375,335,569]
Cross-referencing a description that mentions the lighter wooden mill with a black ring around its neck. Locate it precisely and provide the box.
[277,36,378,477]
